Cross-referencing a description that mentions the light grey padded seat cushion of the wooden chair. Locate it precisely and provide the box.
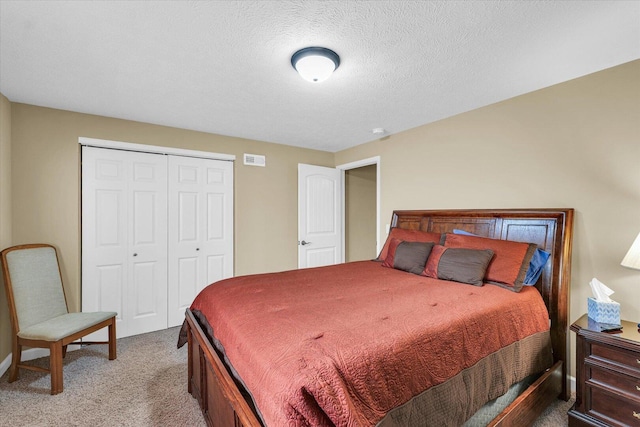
[18,311,117,341]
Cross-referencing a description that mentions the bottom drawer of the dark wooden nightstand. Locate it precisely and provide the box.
[587,388,640,426]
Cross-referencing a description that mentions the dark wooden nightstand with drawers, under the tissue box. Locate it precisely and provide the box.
[569,314,640,426]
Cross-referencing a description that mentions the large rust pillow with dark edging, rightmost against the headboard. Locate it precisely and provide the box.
[444,233,536,292]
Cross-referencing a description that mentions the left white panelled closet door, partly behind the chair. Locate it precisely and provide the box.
[82,147,167,339]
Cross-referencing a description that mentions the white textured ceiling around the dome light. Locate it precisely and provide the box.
[0,0,640,152]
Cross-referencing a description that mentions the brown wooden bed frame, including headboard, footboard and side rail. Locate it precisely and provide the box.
[186,209,573,427]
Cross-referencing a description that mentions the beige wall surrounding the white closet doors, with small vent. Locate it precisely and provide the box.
[0,103,333,360]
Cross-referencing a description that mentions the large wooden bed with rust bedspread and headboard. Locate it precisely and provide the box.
[182,209,573,427]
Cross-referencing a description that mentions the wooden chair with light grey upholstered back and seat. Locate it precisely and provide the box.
[1,244,117,394]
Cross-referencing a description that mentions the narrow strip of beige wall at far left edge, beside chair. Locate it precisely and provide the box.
[0,94,11,362]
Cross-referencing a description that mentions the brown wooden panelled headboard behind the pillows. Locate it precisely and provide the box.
[391,209,573,400]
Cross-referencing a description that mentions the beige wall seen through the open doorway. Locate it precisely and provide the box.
[344,165,378,262]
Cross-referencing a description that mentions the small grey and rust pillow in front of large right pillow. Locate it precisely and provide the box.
[422,245,493,286]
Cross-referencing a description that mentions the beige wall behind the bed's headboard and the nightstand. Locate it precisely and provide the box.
[336,61,640,378]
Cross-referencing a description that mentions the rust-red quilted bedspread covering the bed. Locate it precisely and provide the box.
[191,261,551,427]
